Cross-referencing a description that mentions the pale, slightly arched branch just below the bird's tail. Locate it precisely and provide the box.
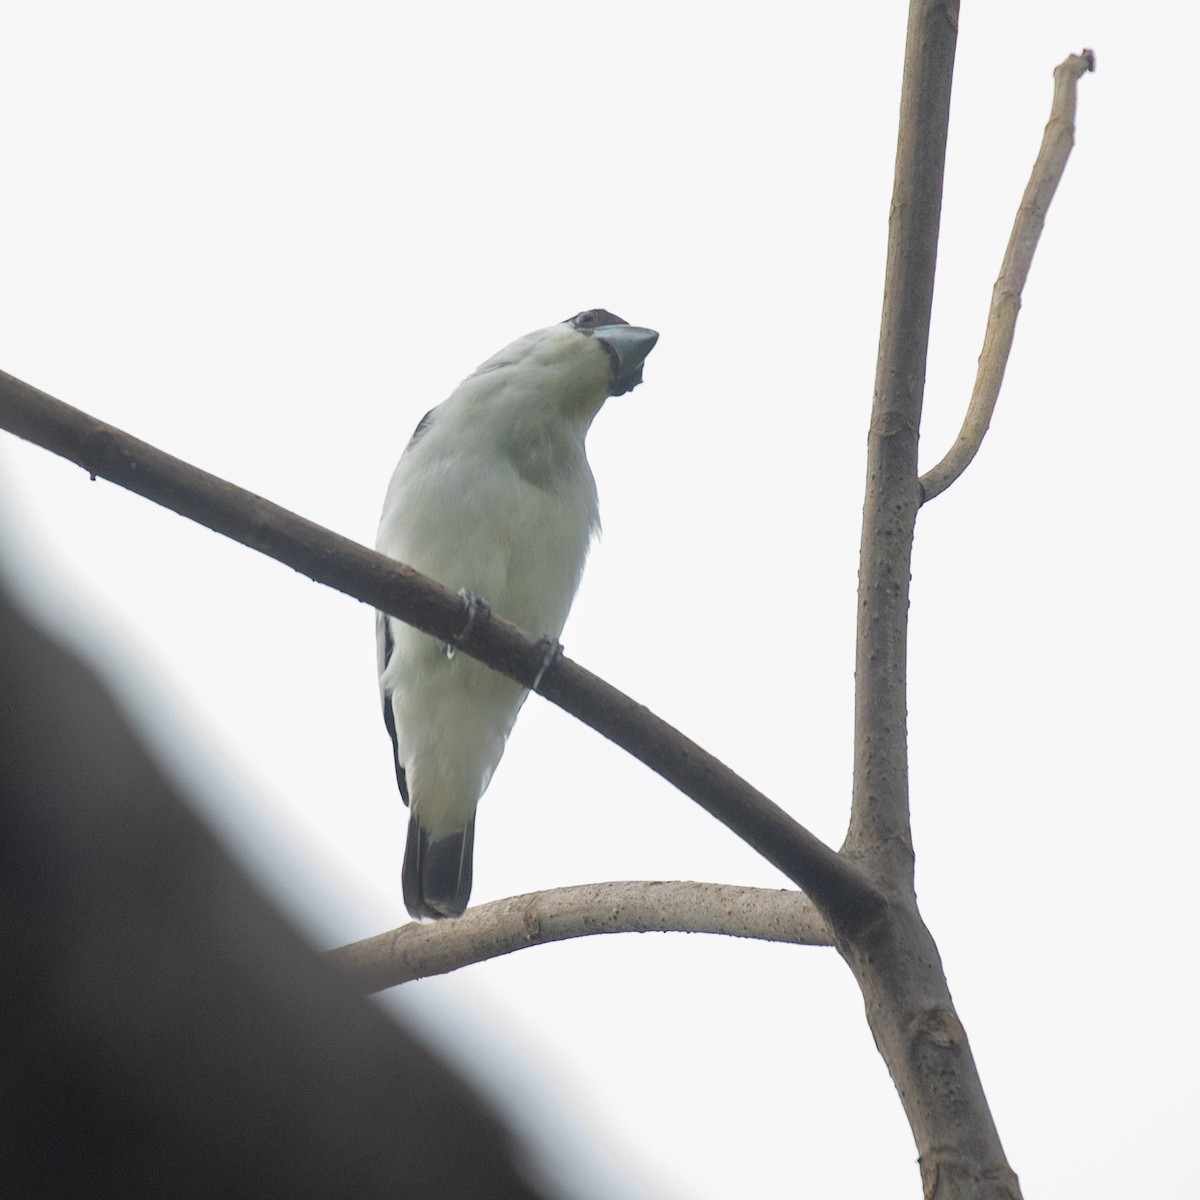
[328,882,833,992]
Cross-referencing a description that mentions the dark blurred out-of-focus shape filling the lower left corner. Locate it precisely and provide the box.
[0,573,546,1200]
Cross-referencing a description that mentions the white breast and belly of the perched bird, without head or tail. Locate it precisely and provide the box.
[377,360,599,835]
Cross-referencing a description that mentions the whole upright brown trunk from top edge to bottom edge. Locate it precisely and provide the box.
[830,0,1020,1200]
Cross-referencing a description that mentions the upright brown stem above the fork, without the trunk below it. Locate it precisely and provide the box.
[846,0,958,892]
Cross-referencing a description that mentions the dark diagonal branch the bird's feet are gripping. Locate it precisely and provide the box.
[0,372,881,924]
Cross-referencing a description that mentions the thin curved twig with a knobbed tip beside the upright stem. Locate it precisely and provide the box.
[920,50,1096,503]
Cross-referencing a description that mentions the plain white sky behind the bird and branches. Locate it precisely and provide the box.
[0,0,1200,1200]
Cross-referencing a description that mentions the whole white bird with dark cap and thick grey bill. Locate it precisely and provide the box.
[376,308,659,919]
